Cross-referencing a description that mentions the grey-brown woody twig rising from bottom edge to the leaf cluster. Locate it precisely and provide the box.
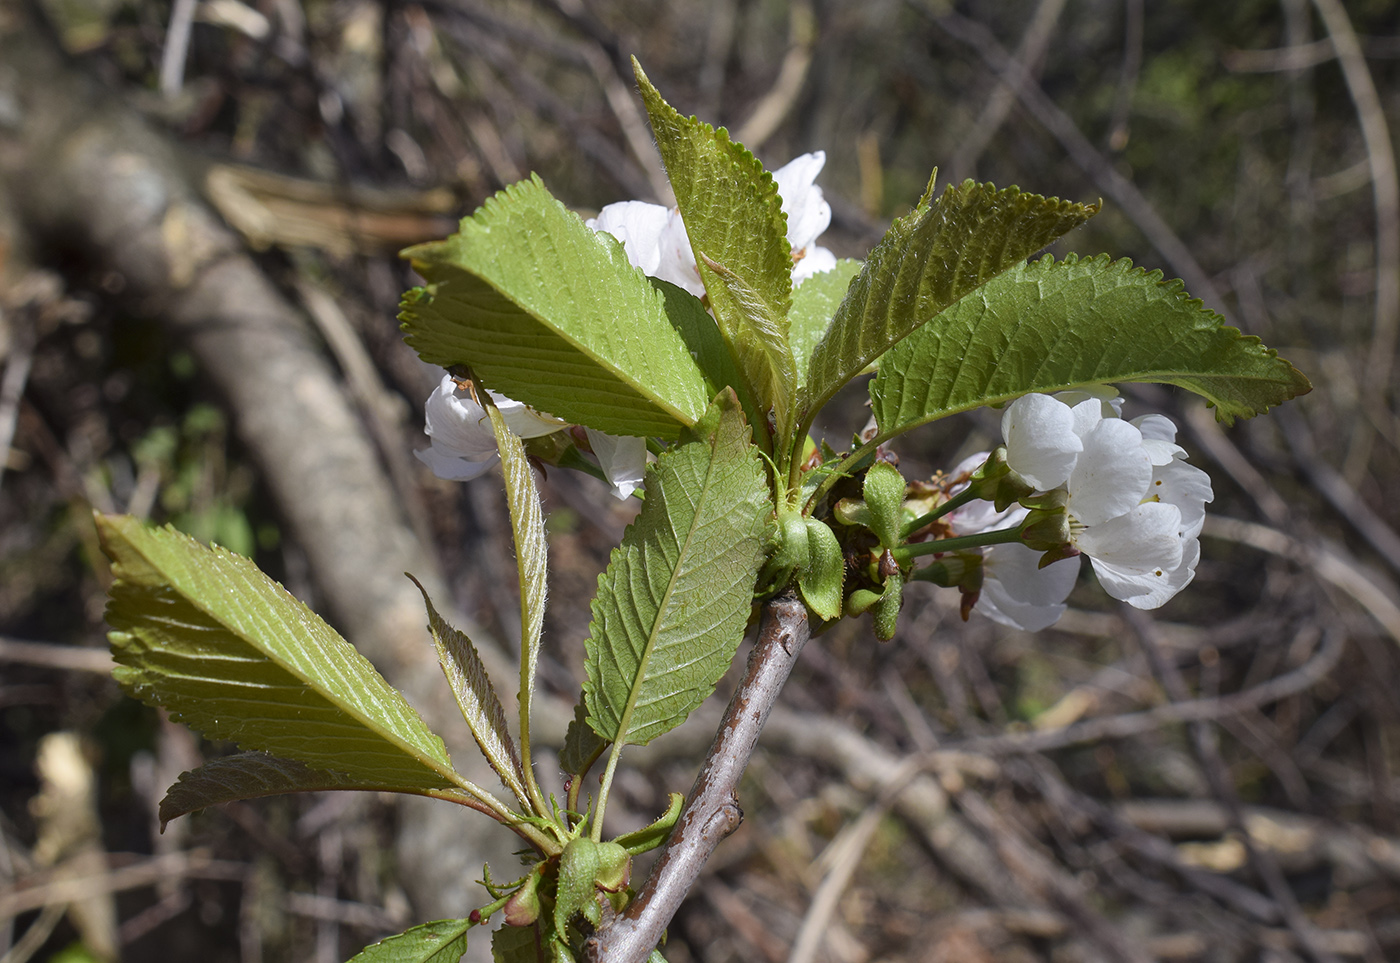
[588,593,812,963]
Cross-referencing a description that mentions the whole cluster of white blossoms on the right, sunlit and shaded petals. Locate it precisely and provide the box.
[949,389,1214,631]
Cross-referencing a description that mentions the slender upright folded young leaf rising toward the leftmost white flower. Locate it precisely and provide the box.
[486,405,549,813]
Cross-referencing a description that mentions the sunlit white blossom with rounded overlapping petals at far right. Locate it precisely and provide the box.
[1001,393,1212,609]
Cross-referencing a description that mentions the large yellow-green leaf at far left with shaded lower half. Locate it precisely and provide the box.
[97,515,469,792]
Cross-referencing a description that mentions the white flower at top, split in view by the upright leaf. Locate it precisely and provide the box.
[587,151,836,297]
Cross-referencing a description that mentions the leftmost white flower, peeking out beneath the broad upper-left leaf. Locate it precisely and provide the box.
[413,375,567,482]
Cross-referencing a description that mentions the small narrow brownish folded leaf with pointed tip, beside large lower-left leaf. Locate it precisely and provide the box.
[409,579,529,809]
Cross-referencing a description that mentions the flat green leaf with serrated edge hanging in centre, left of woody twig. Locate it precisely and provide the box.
[584,392,773,745]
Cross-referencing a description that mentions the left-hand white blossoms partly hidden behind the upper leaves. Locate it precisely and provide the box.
[414,151,836,498]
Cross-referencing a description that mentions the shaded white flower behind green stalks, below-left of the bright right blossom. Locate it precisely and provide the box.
[948,452,1079,631]
